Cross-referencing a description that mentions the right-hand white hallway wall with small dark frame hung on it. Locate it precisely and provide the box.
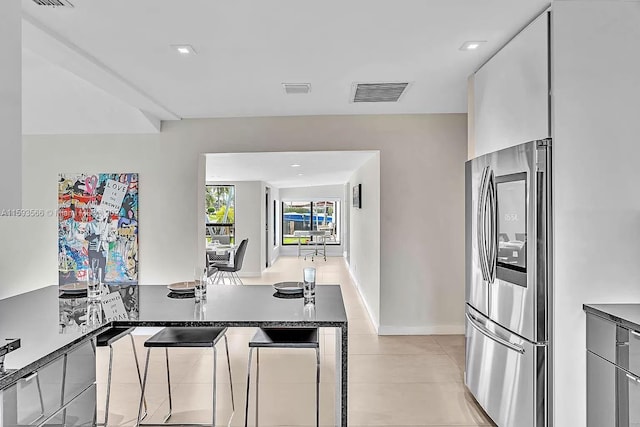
[349,154,382,332]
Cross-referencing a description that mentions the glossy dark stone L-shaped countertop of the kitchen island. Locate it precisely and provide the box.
[0,285,347,389]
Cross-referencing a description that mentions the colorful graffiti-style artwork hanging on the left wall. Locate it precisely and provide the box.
[58,173,138,286]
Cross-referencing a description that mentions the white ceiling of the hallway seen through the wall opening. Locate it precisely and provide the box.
[206,151,376,188]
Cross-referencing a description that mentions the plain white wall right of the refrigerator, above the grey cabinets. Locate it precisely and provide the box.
[552,1,640,427]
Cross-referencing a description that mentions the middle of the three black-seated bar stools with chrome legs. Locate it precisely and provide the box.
[136,327,235,427]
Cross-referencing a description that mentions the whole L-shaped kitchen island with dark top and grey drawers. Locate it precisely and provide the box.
[0,285,347,427]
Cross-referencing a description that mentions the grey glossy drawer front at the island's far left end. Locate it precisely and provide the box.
[0,357,64,427]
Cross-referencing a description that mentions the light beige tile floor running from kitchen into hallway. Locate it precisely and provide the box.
[97,257,493,427]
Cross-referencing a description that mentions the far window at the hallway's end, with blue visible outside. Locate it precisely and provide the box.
[282,200,340,245]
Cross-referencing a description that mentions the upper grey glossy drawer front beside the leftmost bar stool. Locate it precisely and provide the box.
[64,341,96,404]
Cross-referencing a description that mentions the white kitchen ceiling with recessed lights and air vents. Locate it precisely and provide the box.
[22,0,549,133]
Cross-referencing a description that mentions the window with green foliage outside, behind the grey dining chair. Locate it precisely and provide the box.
[205,185,235,244]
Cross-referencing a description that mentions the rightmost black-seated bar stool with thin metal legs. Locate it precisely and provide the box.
[244,328,320,427]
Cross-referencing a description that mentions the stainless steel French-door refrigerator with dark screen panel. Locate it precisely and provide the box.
[465,139,552,427]
